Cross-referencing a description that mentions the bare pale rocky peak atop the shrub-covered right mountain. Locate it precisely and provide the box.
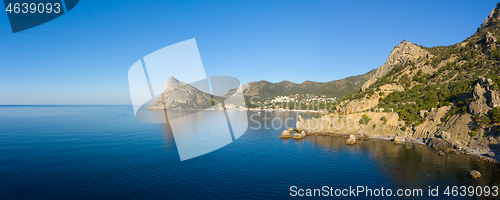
[361,40,431,90]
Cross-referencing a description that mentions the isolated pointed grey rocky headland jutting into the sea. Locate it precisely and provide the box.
[148,76,218,110]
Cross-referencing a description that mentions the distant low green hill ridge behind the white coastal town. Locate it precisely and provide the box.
[242,70,375,98]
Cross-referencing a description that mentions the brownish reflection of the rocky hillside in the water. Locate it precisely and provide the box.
[302,136,500,190]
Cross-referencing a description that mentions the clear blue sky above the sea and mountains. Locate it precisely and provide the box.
[0,0,497,105]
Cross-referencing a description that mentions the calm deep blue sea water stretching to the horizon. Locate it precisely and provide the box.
[0,106,500,199]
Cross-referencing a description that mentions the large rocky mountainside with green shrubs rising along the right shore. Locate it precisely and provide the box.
[330,3,500,153]
